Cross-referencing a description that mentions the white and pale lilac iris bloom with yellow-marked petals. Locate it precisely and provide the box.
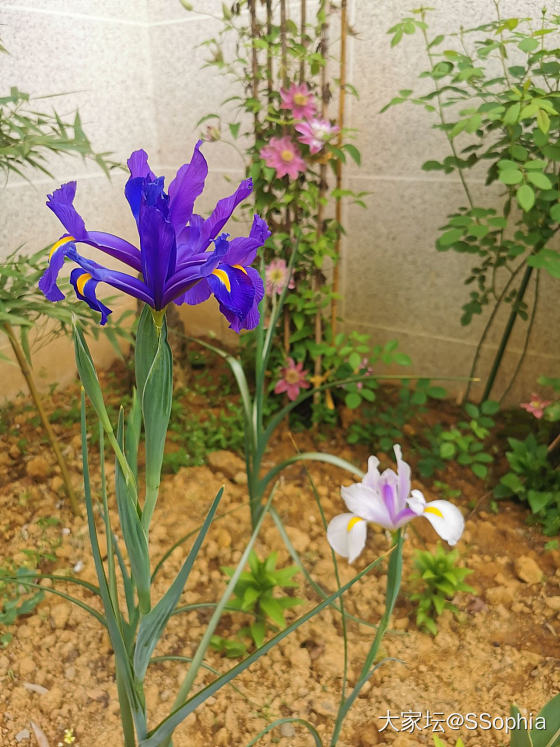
[327,444,465,563]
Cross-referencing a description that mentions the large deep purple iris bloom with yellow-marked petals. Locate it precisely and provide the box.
[39,140,270,332]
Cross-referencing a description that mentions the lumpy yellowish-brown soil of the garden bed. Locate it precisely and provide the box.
[0,352,560,747]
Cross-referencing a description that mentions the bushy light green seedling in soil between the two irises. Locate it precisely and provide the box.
[211,551,303,658]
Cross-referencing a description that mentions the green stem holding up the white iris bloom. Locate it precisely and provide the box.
[330,529,404,747]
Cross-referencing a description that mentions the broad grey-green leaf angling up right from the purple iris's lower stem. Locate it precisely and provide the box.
[134,488,224,681]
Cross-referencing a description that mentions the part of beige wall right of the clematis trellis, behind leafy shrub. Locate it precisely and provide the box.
[342,0,560,403]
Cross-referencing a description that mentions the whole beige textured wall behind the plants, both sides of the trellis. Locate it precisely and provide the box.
[0,0,559,401]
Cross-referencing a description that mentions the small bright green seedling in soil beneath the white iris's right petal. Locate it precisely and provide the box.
[410,544,475,635]
